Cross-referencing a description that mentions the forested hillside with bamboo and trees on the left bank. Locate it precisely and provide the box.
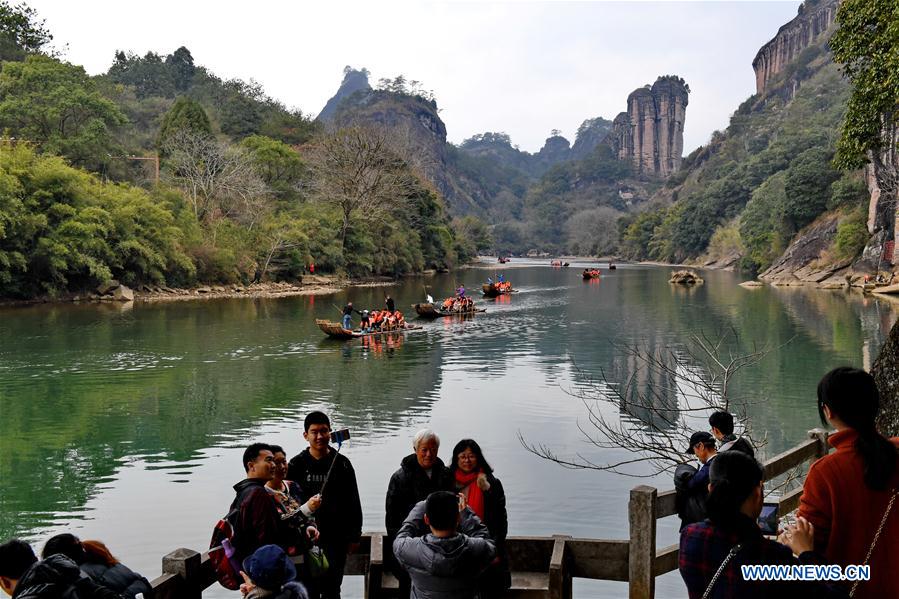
[0,0,489,298]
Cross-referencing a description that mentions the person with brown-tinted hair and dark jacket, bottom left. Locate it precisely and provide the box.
[41,533,153,599]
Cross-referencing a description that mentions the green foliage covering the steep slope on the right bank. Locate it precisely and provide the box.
[621,52,860,269]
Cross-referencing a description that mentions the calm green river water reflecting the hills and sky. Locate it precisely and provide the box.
[0,264,897,597]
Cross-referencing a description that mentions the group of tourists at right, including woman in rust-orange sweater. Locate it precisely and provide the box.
[674,367,899,599]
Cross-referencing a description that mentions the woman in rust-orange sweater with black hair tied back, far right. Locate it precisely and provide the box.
[799,367,899,599]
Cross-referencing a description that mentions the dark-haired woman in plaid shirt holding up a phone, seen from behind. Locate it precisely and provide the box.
[678,451,859,599]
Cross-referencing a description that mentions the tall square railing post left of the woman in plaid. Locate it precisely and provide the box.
[627,485,658,599]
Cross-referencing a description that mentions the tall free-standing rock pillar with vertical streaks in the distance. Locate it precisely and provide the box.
[611,76,690,177]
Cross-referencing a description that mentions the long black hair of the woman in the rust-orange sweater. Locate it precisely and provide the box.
[818,366,897,491]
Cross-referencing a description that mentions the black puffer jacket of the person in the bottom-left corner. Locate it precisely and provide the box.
[12,554,122,599]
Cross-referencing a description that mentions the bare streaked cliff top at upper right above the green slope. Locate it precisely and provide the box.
[752,0,839,94]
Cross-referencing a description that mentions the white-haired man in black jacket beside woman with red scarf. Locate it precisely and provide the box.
[385,429,453,599]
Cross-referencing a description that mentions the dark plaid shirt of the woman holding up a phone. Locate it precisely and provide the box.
[679,518,849,599]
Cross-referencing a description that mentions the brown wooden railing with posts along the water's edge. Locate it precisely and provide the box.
[146,430,828,599]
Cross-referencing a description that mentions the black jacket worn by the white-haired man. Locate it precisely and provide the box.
[385,453,454,547]
